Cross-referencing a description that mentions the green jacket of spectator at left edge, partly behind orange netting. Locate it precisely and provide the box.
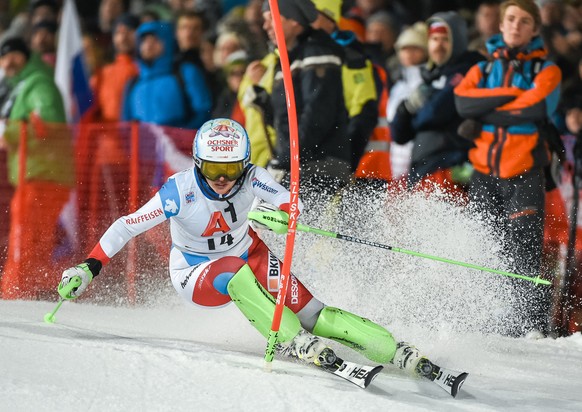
[2,53,74,186]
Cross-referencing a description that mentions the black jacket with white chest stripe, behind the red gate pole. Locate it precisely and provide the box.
[271,30,351,173]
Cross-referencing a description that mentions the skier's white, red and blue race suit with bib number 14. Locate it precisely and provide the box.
[89,165,323,323]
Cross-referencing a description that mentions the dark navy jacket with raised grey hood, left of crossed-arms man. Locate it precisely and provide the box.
[390,12,483,185]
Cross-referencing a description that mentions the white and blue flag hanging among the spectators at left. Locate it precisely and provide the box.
[55,0,93,123]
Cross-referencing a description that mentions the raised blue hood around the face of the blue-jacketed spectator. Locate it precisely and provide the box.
[136,21,176,78]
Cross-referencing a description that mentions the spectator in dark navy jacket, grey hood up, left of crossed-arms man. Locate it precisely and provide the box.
[390,11,483,192]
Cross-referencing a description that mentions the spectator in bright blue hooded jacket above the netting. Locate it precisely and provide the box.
[122,22,212,129]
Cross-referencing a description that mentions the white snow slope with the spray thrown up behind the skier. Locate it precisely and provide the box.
[0,188,582,412]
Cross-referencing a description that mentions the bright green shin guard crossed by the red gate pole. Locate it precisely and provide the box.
[227,264,301,343]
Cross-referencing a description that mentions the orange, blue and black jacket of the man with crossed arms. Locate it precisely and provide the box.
[455,35,561,179]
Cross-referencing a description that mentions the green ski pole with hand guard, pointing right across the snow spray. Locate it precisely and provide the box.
[248,211,551,285]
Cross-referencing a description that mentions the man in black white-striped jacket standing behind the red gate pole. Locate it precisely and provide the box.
[269,0,351,193]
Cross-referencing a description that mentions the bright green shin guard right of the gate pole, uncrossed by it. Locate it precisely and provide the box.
[313,306,396,363]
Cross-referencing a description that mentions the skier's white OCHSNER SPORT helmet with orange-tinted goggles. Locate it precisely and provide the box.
[192,118,251,181]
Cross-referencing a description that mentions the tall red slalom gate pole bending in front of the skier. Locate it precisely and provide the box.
[265,0,299,369]
